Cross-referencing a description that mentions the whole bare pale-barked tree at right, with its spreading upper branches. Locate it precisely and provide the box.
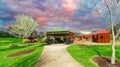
[80,0,120,65]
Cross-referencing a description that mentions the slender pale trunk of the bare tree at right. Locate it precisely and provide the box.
[111,23,115,65]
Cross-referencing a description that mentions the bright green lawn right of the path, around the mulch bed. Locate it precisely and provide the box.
[67,45,120,67]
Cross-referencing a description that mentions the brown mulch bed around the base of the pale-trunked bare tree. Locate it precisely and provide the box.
[92,56,120,67]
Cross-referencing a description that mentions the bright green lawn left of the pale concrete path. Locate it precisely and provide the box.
[0,38,44,67]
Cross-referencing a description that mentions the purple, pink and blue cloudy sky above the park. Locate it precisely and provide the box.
[0,0,120,31]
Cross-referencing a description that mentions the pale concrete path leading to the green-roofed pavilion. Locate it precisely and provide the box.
[35,44,82,67]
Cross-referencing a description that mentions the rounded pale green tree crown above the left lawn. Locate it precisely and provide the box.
[9,14,38,38]
